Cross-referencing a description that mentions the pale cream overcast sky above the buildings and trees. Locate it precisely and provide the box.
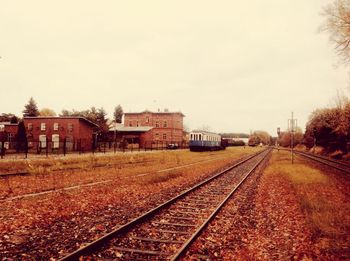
[0,0,348,135]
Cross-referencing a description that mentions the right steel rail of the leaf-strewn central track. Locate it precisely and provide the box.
[171,149,271,261]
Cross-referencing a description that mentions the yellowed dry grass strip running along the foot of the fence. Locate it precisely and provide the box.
[0,148,257,198]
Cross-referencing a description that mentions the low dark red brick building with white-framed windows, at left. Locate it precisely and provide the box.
[23,116,98,151]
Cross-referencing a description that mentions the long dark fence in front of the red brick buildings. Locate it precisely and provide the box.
[0,139,188,159]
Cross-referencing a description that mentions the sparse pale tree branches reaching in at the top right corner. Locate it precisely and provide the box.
[322,0,350,64]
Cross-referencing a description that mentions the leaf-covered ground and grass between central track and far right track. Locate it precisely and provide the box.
[184,149,350,260]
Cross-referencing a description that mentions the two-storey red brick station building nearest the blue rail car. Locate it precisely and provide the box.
[124,110,185,147]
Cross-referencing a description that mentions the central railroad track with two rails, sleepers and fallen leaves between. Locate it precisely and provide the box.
[61,149,271,260]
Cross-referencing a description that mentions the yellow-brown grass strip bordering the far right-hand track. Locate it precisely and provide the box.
[265,151,350,250]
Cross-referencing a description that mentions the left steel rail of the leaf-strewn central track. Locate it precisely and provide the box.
[59,149,268,261]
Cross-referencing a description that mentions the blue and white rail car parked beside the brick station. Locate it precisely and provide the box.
[188,130,227,151]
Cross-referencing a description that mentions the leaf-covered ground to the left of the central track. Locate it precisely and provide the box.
[0,148,257,259]
